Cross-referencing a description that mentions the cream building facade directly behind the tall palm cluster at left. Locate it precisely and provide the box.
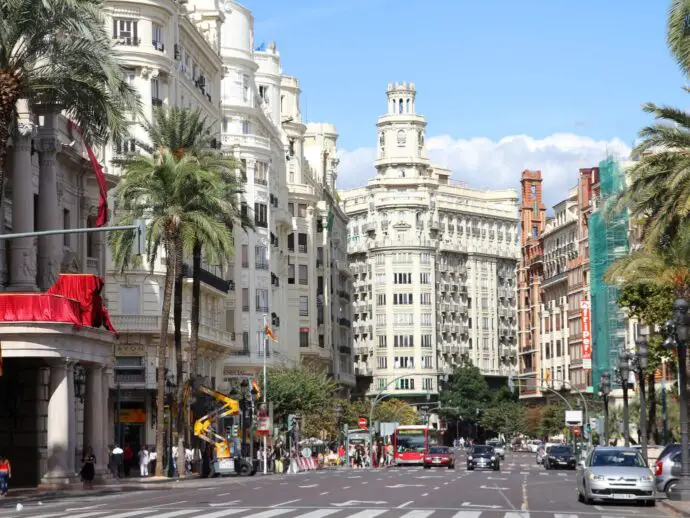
[102,0,230,448]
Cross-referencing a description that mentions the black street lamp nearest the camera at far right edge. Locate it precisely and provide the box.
[664,299,690,501]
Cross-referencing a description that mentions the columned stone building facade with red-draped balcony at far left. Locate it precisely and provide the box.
[0,107,115,486]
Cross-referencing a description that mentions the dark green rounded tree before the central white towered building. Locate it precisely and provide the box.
[441,363,492,421]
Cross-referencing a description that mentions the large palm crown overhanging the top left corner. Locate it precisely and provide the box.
[0,0,140,217]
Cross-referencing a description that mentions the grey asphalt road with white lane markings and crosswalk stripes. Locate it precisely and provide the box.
[0,454,669,518]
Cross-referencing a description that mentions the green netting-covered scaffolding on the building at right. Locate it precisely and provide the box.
[589,157,629,394]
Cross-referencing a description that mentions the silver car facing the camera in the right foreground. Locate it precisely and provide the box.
[577,447,656,506]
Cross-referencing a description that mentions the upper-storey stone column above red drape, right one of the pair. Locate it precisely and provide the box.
[36,112,64,291]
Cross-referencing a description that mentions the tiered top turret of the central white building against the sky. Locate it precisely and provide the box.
[374,83,429,178]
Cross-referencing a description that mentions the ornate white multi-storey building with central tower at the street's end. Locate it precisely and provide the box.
[341,83,519,400]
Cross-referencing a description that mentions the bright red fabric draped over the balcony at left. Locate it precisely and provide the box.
[0,273,117,334]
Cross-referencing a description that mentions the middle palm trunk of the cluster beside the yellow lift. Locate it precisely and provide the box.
[173,236,185,476]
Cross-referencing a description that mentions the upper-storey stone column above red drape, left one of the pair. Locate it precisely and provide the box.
[8,108,37,291]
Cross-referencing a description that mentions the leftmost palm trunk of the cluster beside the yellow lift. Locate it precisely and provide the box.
[156,242,175,477]
